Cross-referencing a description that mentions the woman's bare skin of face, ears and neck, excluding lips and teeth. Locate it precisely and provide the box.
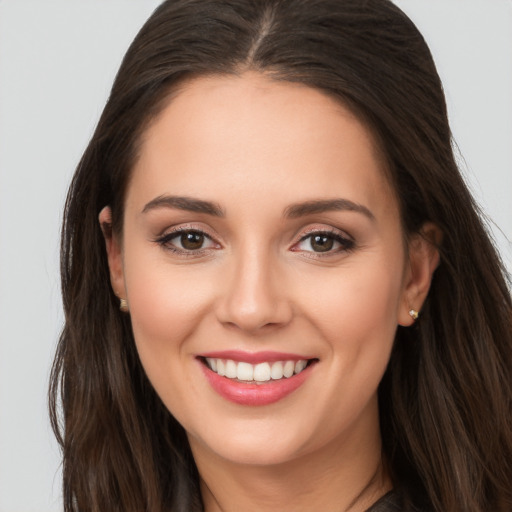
[100,73,438,512]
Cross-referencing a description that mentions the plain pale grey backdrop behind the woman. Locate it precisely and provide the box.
[0,0,512,512]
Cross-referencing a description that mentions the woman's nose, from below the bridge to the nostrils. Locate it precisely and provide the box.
[217,249,293,333]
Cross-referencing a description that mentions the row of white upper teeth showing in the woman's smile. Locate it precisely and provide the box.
[206,357,308,382]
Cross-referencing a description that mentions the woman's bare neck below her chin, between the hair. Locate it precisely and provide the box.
[191,412,391,512]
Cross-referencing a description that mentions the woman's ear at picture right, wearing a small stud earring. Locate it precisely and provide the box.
[398,222,442,326]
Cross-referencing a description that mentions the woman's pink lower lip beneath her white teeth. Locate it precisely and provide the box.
[200,363,313,406]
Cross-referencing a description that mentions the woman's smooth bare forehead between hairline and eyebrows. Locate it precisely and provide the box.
[128,73,394,219]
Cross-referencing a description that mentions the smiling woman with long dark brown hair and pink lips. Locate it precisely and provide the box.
[51,0,512,512]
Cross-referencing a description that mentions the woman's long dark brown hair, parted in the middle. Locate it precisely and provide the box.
[50,0,512,512]
